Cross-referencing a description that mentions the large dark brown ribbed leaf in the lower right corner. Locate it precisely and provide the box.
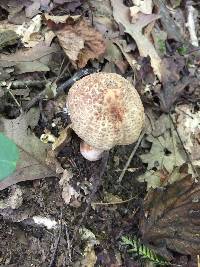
[140,174,200,260]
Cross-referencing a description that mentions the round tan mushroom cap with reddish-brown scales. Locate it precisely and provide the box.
[67,73,144,150]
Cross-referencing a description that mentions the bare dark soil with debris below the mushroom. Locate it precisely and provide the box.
[0,138,145,267]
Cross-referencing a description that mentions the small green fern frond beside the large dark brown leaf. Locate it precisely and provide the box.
[122,236,171,266]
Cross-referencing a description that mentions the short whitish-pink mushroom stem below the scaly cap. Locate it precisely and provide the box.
[80,141,104,161]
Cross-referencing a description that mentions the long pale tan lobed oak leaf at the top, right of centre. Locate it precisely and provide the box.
[111,0,161,79]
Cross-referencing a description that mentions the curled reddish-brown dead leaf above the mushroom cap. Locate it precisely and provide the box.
[46,16,105,68]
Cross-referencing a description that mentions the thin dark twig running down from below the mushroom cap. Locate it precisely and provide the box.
[71,151,109,243]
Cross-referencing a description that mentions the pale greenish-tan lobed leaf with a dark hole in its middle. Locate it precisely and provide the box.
[138,125,187,190]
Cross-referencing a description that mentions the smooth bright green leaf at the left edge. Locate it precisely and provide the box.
[0,133,19,181]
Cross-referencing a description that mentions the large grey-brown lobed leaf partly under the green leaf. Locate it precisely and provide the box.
[0,110,55,190]
